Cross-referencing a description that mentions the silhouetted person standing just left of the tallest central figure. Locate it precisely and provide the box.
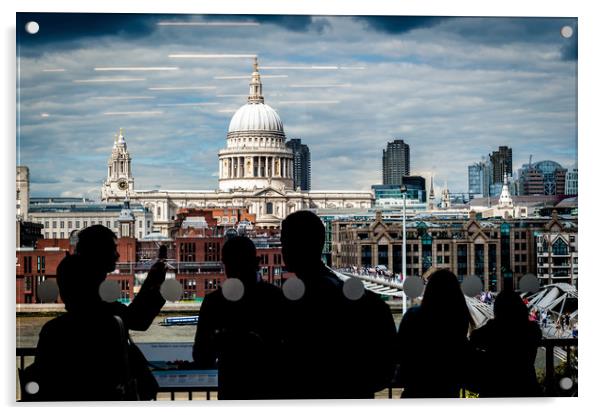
[193,236,283,399]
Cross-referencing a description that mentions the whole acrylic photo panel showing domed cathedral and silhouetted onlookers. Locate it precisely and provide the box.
[16,13,578,401]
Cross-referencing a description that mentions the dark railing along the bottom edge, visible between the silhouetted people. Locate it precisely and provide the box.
[16,338,578,401]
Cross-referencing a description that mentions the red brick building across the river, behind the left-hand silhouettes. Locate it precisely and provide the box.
[16,234,292,303]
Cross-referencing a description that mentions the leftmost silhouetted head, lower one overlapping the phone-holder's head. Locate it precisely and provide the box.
[56,254,104,311]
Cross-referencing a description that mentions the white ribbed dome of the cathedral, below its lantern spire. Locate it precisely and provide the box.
[228,102,284,133]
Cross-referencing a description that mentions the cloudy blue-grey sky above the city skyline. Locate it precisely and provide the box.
[17,13,577,198]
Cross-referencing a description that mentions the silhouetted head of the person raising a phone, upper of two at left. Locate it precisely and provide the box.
[75,225,119,274]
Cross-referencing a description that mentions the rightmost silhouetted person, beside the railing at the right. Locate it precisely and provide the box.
[470,290,541,397]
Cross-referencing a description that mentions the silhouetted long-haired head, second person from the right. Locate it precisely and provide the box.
[420,269,473,336]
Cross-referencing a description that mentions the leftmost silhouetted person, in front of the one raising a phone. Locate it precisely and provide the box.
[26,255,131,401]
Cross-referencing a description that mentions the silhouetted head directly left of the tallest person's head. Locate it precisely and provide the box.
[222,236,259,283]
